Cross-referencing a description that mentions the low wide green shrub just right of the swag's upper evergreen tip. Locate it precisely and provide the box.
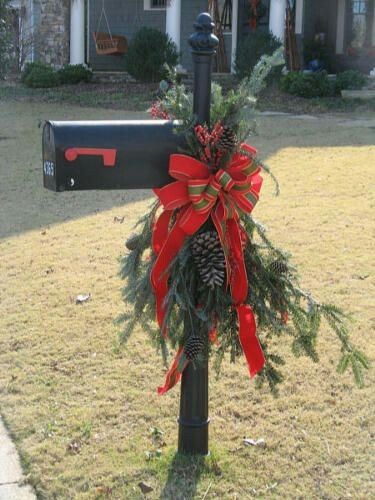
[280,71,333,98]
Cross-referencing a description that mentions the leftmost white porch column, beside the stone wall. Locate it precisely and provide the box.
[70,0,85,64]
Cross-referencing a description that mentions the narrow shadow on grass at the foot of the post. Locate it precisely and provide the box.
[160,453,206,500]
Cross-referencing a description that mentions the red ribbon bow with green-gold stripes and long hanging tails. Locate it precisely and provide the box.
[151,144,264,393]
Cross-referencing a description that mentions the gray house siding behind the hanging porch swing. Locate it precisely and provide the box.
[89,0,165,71]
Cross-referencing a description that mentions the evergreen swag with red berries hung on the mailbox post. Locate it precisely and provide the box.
[119,49,368,393]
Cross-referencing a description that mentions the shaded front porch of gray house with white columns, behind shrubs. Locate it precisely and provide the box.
[70,0,290,72]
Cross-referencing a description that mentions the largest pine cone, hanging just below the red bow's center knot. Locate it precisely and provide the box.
[191,230,225,288]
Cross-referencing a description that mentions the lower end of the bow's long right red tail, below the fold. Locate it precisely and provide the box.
[236,304,265,377]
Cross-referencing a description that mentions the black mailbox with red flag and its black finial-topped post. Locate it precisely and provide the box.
[43,13,218,455]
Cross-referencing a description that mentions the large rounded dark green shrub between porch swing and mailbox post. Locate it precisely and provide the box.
[125,27,178,82]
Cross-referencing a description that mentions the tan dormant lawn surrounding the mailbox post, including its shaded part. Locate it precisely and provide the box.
[0,102,375,500]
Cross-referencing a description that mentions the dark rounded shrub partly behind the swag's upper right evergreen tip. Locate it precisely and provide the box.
[235,31,282,79]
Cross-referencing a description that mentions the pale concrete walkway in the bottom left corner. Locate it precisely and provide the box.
[0,418,36,500]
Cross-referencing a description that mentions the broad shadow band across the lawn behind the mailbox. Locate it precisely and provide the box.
[0,97,374,240]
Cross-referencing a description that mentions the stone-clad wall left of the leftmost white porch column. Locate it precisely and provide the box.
[34,0,70,68]
